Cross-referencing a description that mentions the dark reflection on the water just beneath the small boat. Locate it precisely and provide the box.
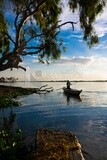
[63,93,82,105]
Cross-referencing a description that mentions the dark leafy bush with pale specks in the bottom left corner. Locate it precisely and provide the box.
[0,112,26,160]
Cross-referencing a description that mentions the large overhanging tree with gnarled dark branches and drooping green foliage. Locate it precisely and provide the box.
[0,0,105,71]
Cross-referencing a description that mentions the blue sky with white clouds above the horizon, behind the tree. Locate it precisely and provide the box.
[0,0,107,81]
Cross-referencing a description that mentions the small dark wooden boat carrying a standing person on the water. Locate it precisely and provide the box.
[63,87,82,96]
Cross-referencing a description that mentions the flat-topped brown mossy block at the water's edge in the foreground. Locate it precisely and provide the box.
[34,129,85,160]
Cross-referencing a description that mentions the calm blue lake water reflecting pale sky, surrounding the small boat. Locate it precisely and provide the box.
[0,82,107,160]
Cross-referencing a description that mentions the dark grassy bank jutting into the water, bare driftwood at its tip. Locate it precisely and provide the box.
[0,85,53,108]
